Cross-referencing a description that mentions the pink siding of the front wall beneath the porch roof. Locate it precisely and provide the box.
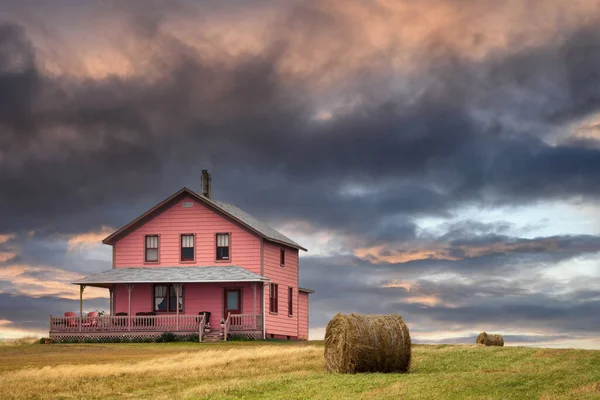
[115,283,261,328]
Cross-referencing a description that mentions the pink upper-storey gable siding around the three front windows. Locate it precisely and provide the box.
[114,197,262,273]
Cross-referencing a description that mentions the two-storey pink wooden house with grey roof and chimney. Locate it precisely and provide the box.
[50,170,314,340]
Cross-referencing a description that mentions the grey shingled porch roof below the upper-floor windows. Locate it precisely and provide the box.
[72,266,269,287]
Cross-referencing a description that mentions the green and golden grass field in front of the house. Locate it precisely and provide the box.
[0,342,600,400]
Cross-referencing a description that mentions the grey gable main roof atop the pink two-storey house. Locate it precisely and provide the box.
[102,187,307,251]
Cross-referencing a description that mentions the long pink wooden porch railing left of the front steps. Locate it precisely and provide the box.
[50,315,204,332]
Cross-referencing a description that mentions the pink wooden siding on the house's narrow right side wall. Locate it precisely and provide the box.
[263,240,298,337]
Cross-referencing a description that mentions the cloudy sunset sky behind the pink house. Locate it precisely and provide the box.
[0,0,600,348]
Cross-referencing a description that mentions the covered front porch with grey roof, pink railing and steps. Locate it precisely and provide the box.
[49,266,268,340]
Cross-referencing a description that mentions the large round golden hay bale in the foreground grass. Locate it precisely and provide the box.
[325,314,411,373]
